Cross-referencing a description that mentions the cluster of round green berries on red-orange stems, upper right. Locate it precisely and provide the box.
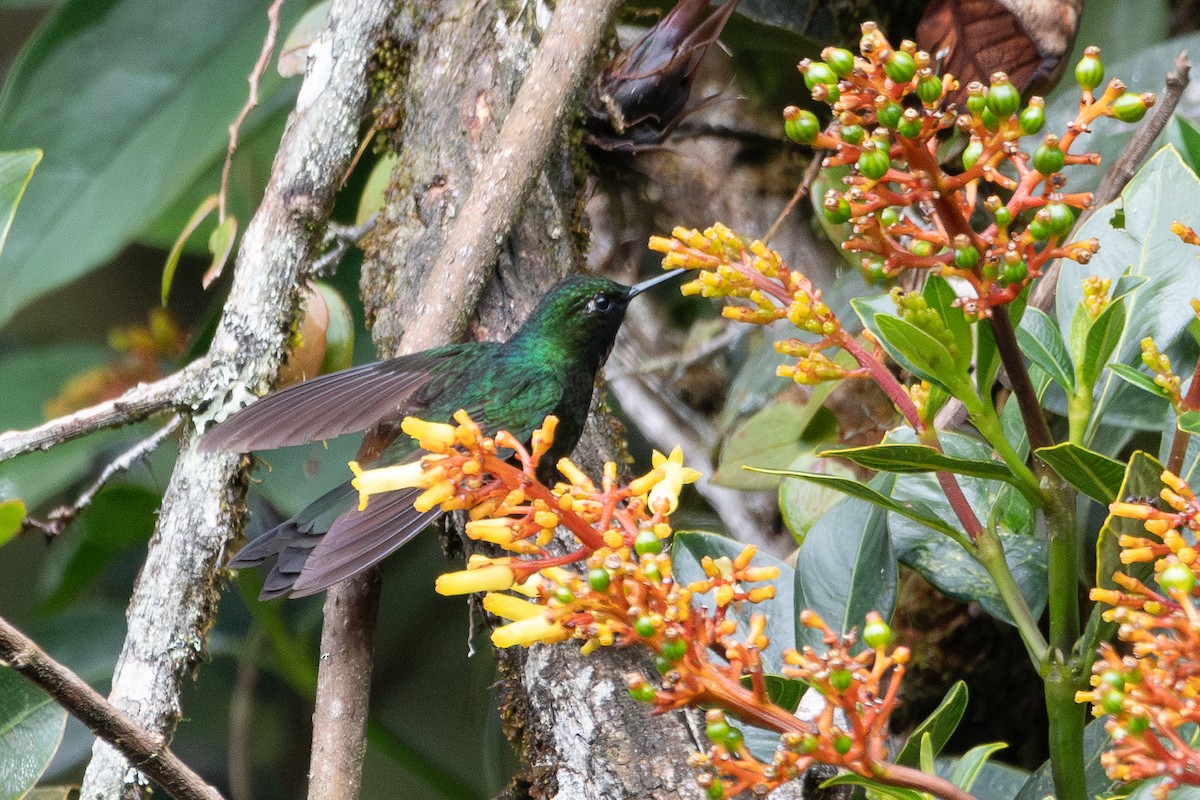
[784,23,1154,317]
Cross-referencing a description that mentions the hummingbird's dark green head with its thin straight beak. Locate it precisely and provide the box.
[517,270,683,369]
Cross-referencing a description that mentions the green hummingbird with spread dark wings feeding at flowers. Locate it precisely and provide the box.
[199,270,684,600]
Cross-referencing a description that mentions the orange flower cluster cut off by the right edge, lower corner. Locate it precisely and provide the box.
[1076,471,1200,800]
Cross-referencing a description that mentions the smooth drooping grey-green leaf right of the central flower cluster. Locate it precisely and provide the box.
[794,475,899,652]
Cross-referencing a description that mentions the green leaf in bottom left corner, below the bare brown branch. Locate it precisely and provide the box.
[0,666,67,799]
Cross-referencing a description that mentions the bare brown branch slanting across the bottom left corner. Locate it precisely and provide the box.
[0,618,221,800]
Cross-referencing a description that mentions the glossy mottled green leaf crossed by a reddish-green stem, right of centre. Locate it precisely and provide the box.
[888,428,1048,624]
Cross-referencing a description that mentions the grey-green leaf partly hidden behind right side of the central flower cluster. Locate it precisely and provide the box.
[671,531,796,674]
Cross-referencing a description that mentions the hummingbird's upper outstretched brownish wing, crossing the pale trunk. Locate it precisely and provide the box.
[200,344,478,452]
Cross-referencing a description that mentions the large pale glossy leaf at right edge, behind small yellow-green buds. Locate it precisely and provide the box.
[1057,148,1200,444]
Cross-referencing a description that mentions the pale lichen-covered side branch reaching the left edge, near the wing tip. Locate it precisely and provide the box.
[0,357,204,461]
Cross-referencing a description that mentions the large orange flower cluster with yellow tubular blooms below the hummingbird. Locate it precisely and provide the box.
[352,411,953,798]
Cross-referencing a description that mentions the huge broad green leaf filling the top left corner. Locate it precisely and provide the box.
[0,0,302,324]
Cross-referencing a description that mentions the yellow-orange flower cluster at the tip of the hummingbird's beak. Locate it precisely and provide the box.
[649,222,866,384]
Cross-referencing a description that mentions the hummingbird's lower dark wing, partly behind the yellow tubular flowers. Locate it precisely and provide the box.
[288,489,442,597]
